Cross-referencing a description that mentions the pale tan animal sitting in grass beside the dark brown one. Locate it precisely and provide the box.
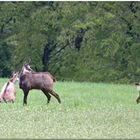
[0,73,18,103]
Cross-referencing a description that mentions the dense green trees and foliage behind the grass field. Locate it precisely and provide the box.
[0,1,140,83]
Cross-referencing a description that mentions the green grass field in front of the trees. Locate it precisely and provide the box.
[0,79,140,139]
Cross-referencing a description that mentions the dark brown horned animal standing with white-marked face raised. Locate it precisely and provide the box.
[19,64,61,105]
